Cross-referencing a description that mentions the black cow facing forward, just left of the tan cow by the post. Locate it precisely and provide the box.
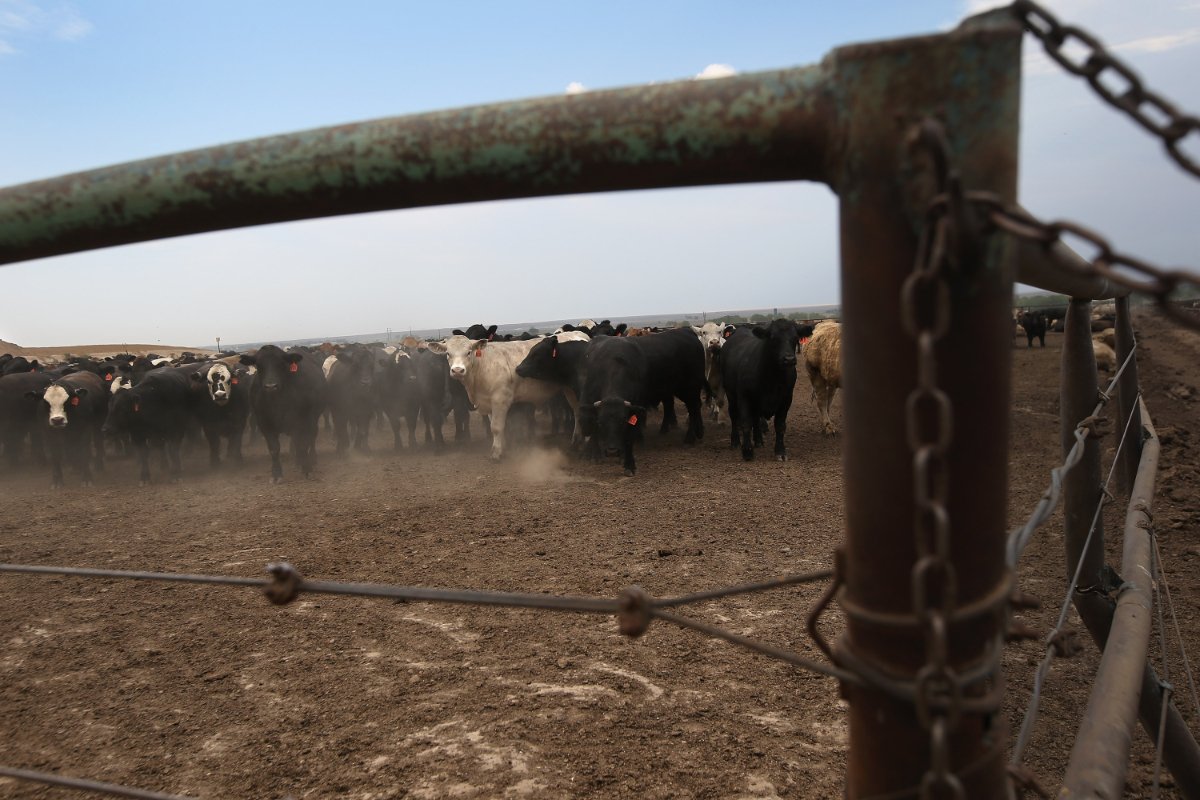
[721,319,811,461]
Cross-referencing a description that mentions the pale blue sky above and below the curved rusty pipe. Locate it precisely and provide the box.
[0,0,1200,347]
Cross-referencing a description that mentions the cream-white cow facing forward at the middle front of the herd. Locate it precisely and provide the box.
[430,331,589,461]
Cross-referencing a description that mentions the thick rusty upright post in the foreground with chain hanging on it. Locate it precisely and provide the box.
[827,17,1020,800]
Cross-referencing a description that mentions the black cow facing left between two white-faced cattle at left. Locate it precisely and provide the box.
[103,368,192,486]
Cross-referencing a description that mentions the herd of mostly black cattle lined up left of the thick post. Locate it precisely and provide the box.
[0,319,854,487]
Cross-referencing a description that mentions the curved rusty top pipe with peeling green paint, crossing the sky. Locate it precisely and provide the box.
[0,66,833,264]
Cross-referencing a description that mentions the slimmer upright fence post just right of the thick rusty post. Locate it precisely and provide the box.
[1058,297,1112,642]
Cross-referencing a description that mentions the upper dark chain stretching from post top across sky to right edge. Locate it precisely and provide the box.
[1012,0,1200,178]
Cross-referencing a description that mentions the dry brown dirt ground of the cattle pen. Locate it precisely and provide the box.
[0,317,1200,800]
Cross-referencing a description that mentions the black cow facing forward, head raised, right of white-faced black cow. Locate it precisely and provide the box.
[241,344,326,483]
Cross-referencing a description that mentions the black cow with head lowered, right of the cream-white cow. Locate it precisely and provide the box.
[580,327,704,475]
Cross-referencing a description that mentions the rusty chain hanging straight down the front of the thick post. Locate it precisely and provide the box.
[900,119,966,800]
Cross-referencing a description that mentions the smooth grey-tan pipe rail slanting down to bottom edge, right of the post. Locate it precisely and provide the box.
[1060,398,1159,798]
